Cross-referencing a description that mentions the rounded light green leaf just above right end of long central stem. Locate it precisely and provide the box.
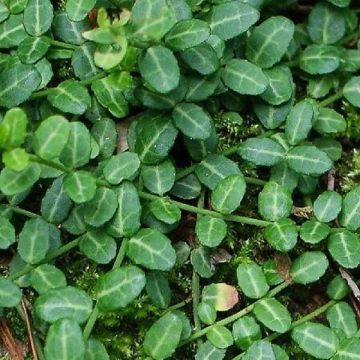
[258,181,293,221]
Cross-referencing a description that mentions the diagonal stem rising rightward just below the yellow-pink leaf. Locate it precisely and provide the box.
[179,282,289,347]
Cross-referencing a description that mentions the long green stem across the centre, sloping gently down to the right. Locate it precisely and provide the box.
[139,191,272,227]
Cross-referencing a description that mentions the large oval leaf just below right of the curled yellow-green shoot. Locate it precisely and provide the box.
[139,45,180,94]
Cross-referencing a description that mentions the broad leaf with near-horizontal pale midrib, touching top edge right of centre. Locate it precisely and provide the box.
[209,1,260,40]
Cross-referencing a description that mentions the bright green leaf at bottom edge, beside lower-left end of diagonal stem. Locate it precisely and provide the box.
[144,312,183,360]
